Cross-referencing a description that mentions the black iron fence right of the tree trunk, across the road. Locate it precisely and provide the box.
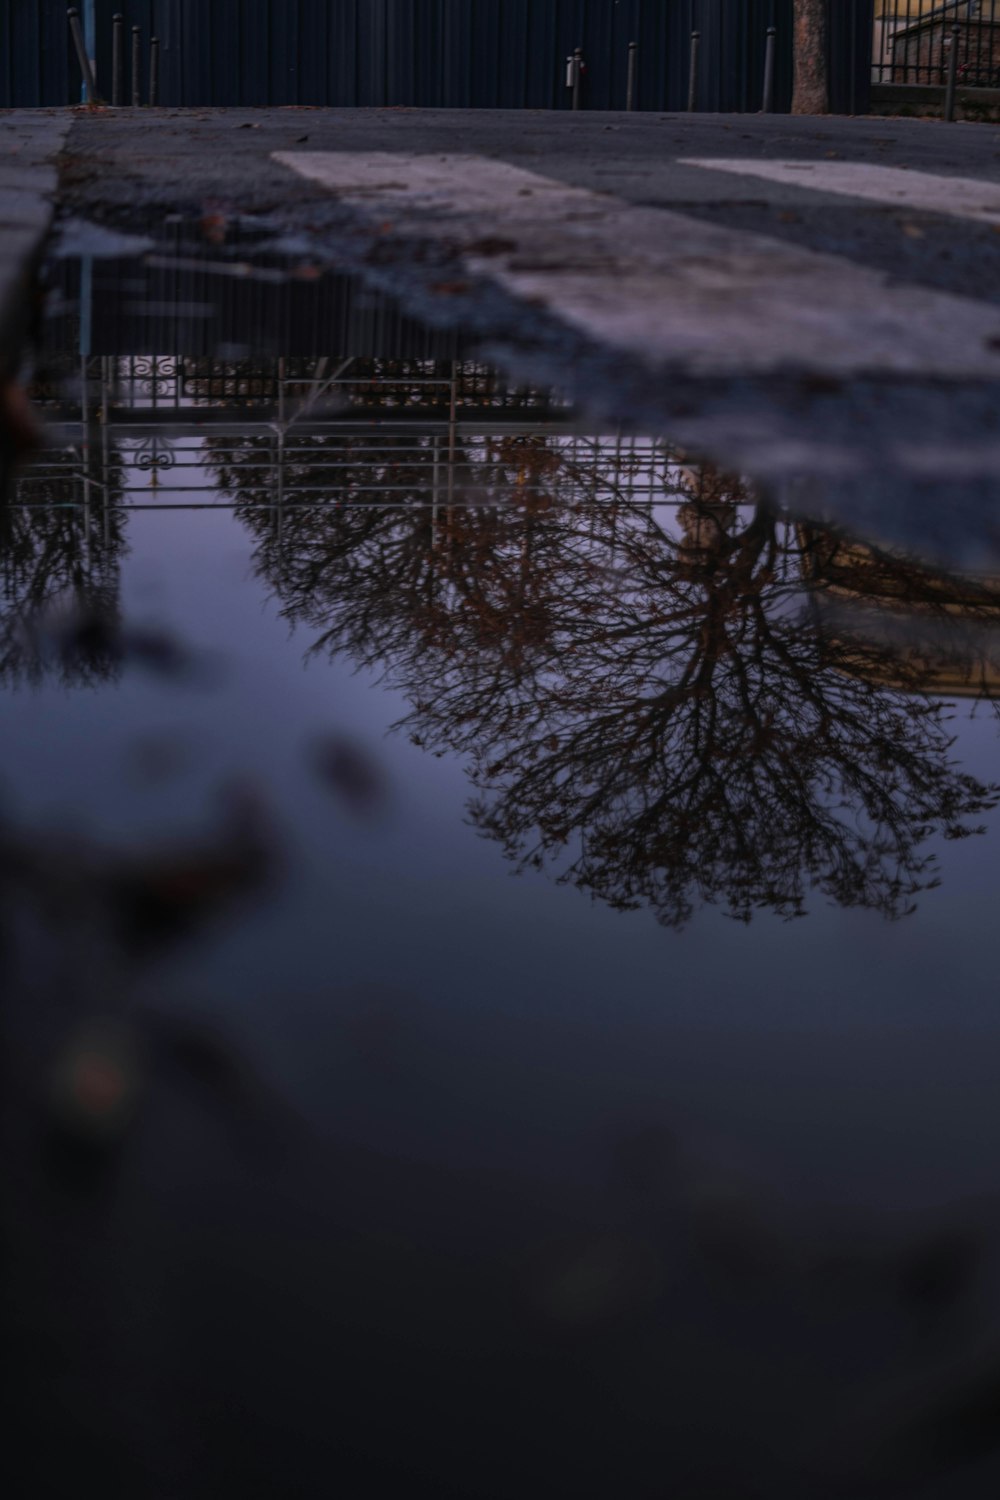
[874,0,1000,89]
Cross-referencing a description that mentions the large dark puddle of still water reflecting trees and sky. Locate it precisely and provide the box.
[0,222,1000,1497]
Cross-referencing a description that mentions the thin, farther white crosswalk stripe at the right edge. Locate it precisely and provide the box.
[678,156,1000,225]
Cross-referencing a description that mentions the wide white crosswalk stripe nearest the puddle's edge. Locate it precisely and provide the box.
[276,152,1000,380]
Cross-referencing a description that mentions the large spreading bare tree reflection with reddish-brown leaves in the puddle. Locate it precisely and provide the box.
[236,438,997,926]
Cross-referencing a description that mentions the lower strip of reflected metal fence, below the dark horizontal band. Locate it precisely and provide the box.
[12,425,710,516]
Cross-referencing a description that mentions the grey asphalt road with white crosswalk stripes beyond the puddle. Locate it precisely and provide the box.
[46,110,1000,563]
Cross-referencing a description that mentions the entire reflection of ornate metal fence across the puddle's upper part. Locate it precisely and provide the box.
[25,356,710,518]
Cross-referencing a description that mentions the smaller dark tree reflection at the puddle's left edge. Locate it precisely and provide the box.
[0,456,124,686]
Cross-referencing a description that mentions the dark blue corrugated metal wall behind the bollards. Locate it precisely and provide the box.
[0,0,873,113]
